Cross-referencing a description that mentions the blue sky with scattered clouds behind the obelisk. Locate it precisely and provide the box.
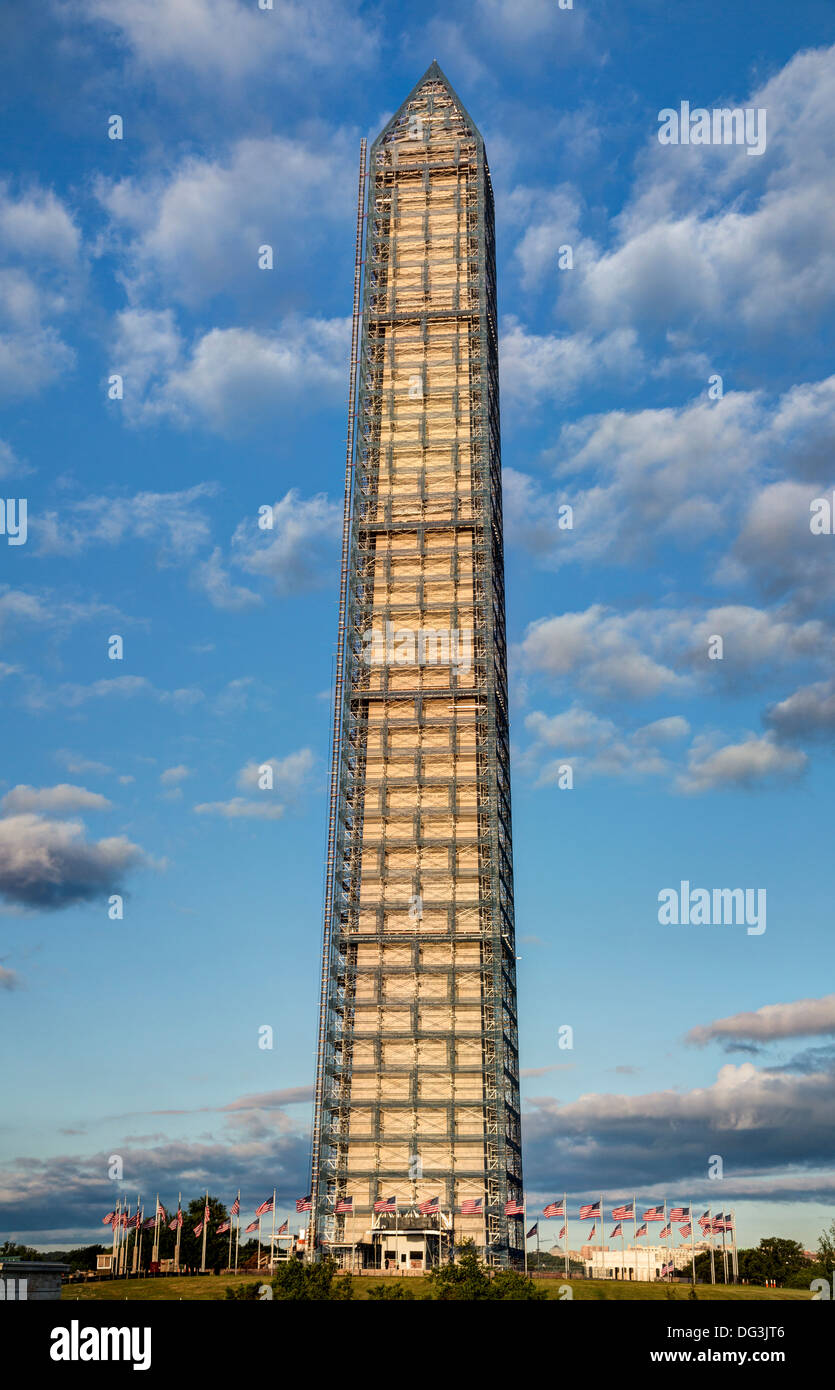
[0,0,835,1245]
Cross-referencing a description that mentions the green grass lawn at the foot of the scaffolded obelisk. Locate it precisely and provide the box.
[61,1275,810,1302]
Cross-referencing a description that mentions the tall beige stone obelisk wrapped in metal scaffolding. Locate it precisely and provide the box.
[308,64,524,1268]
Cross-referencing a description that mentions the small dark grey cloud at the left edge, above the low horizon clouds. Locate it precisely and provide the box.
[0,813,147,910]
